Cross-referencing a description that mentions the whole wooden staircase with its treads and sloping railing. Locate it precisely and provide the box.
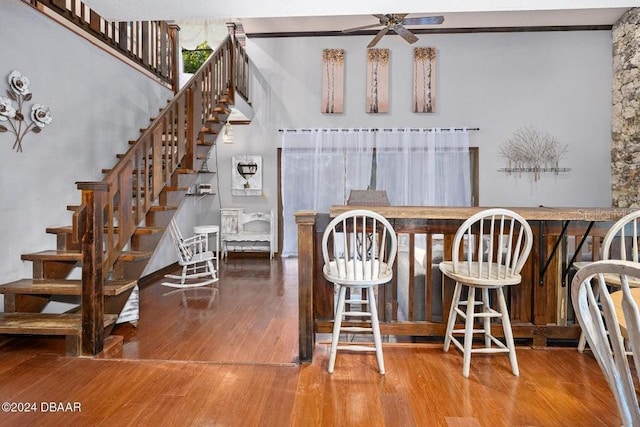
[0,26,248,356]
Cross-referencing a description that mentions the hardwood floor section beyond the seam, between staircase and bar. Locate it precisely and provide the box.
[118,258,298,363]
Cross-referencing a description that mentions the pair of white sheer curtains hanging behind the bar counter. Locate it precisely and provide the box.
[281,128,471,256]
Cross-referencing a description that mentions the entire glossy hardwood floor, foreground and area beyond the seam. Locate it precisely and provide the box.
[0,258,620,427]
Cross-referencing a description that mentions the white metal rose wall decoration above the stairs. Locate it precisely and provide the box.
[0,70,52,152]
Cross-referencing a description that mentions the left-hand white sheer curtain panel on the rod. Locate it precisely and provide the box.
[281,129,375,256]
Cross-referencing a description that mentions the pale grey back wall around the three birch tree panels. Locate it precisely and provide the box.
[219,31,612,227]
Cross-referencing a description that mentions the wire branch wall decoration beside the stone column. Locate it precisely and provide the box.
[499,127,571,181]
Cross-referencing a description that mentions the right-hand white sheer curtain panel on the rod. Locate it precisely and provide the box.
[376,128,471,206]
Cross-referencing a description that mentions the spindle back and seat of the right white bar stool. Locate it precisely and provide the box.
[452,208,533,280]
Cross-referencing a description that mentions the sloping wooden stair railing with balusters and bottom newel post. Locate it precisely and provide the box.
[74,36,248,354]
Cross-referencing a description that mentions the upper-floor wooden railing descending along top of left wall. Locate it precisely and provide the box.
[23,0,179,92]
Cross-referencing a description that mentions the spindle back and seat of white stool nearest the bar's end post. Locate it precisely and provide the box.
[322,209,398,284]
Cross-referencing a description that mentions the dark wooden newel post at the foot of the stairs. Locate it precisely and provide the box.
[78,182,109,356]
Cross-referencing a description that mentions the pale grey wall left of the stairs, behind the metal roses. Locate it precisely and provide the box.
[0,0,172,283]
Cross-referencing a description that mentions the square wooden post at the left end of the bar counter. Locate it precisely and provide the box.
[295,211,316,362]
